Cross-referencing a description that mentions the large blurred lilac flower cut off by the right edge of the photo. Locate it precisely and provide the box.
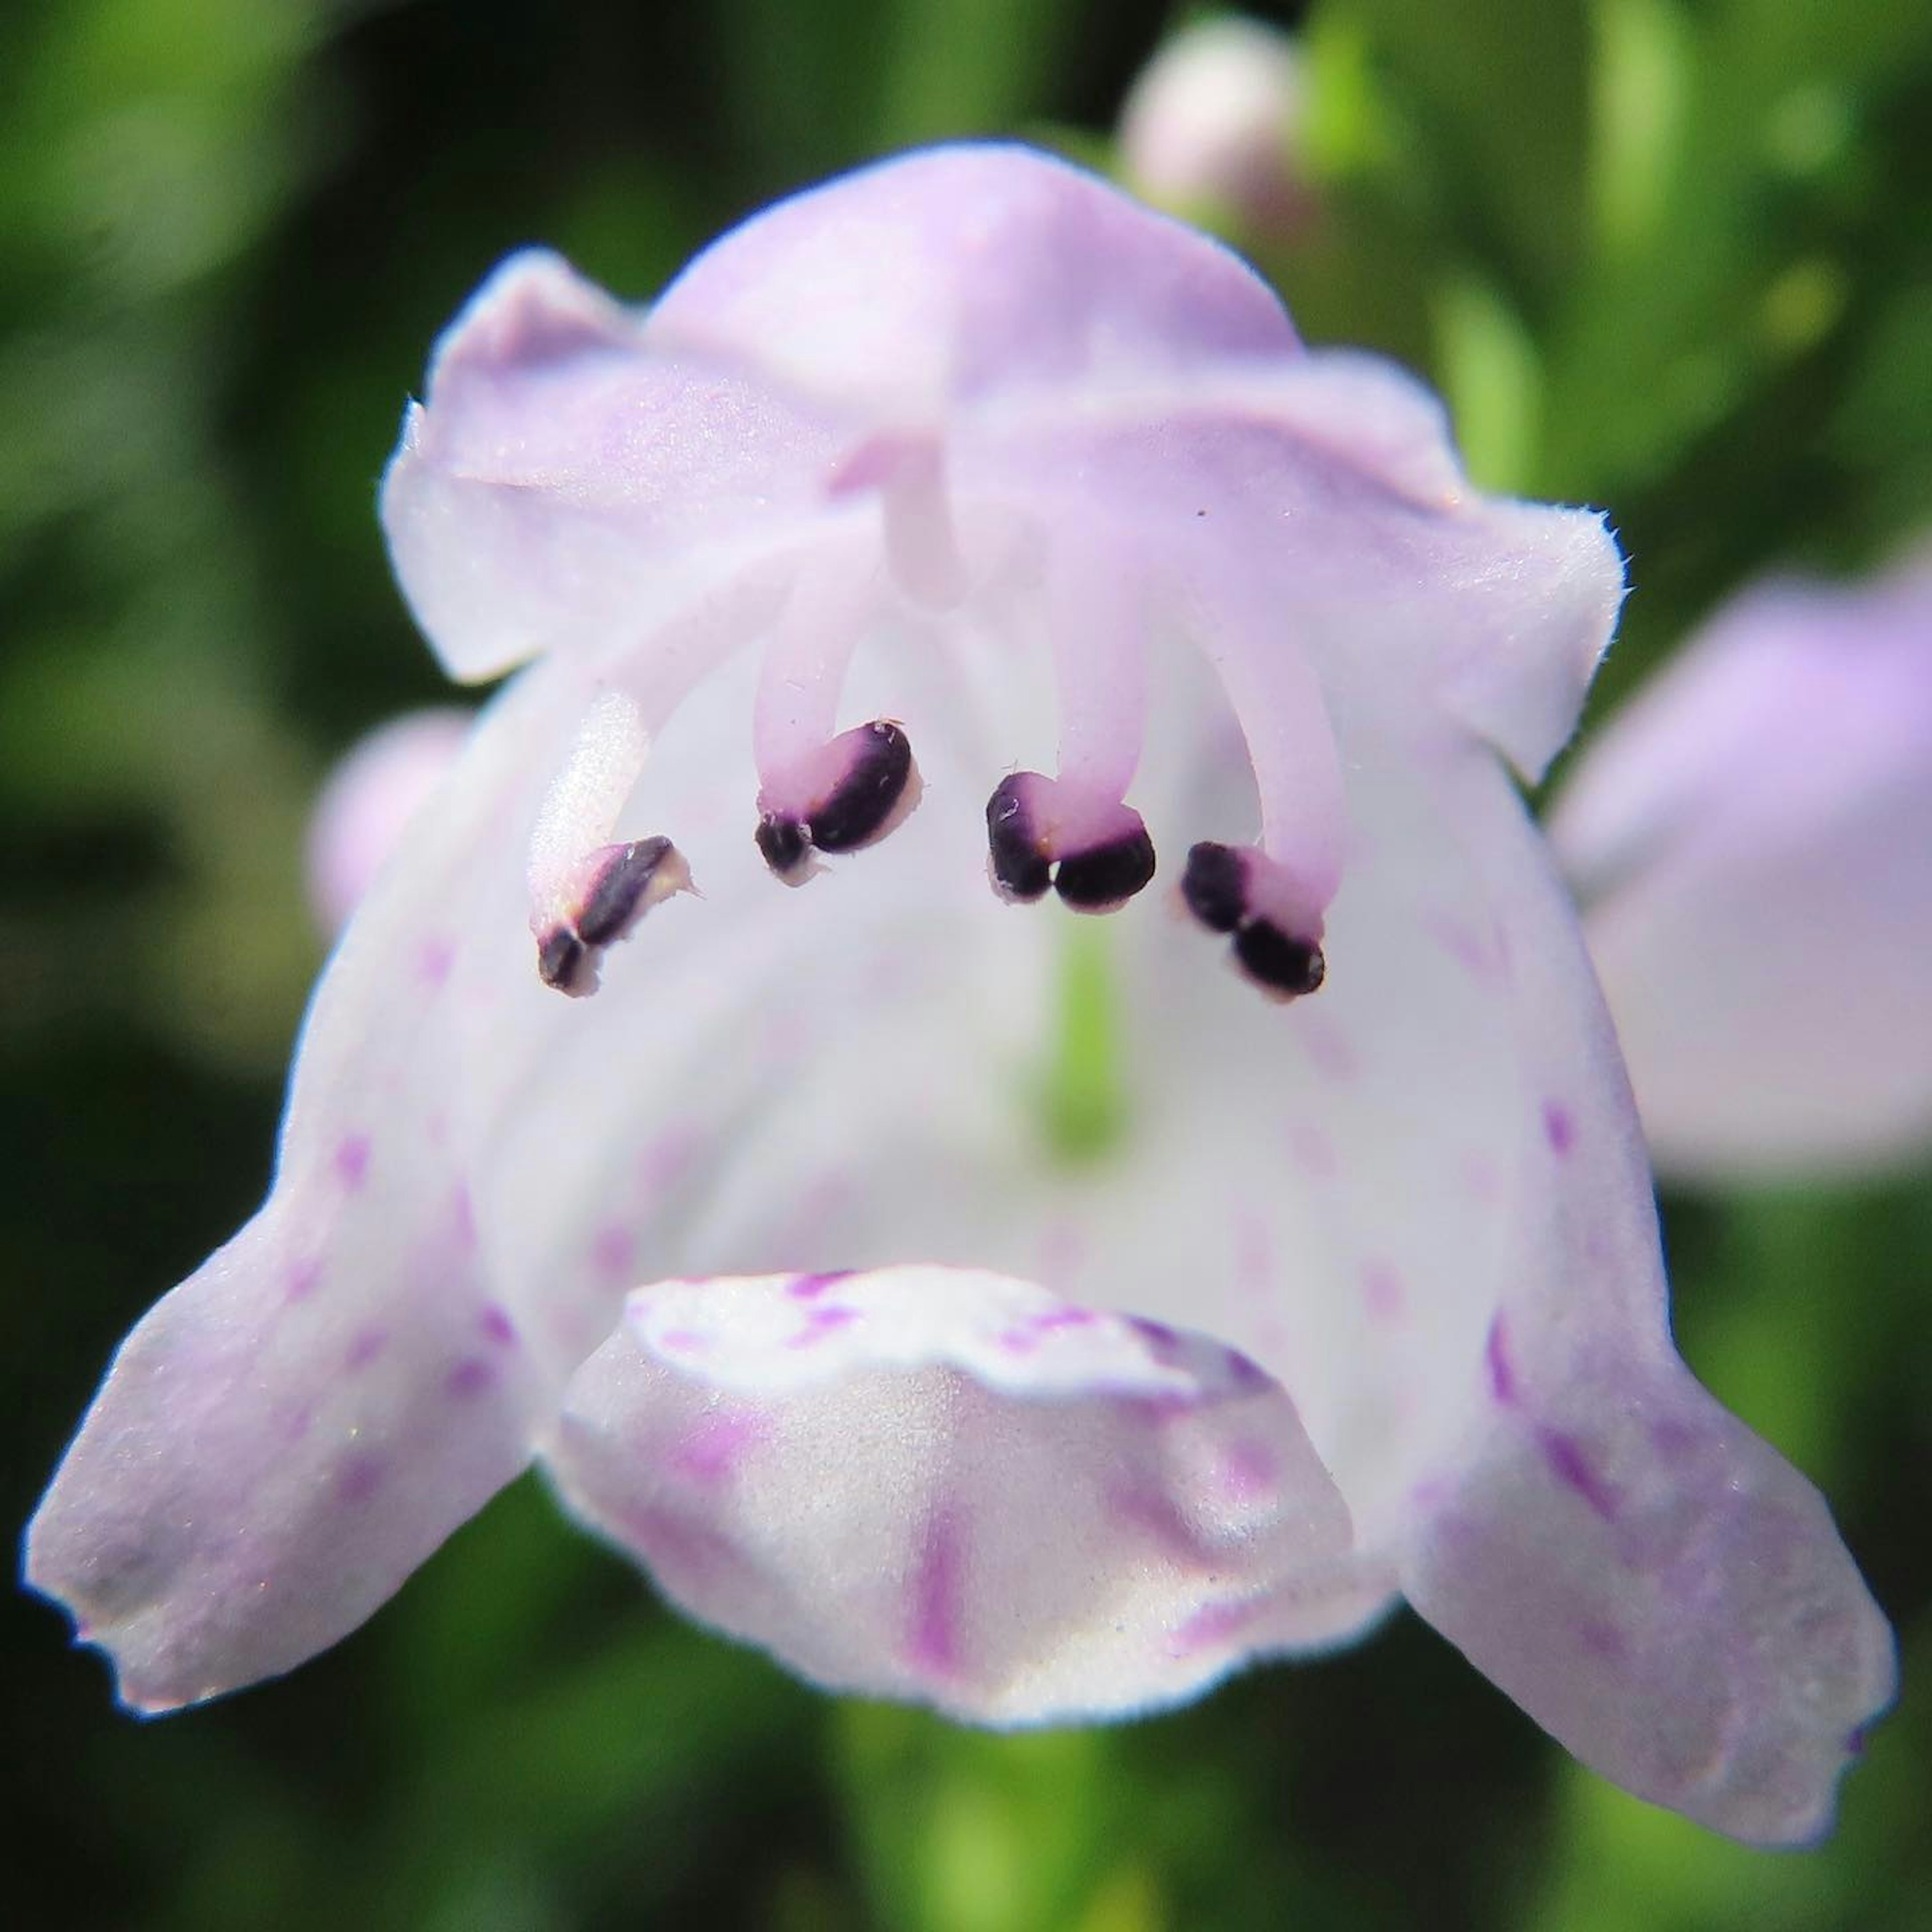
[1552,560,1932,1180]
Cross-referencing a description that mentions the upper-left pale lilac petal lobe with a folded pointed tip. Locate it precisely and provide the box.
[382,251,850,680]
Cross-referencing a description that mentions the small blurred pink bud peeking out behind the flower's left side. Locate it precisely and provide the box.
[307,705,475,937]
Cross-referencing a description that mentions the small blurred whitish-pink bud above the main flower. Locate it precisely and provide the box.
[1120,14,1318,239]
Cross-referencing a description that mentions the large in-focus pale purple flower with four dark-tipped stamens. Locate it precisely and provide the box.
[29,147,1893,1841]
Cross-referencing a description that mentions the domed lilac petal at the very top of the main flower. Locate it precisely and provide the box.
[646,143,1297,421]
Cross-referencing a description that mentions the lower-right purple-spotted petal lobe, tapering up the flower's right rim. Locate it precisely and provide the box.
[1401,742,1895,1843]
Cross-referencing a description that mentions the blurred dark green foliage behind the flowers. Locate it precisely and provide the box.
[0,0,1932,1932]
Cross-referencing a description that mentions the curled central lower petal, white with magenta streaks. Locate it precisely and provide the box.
[547,1267,1387,1723]
